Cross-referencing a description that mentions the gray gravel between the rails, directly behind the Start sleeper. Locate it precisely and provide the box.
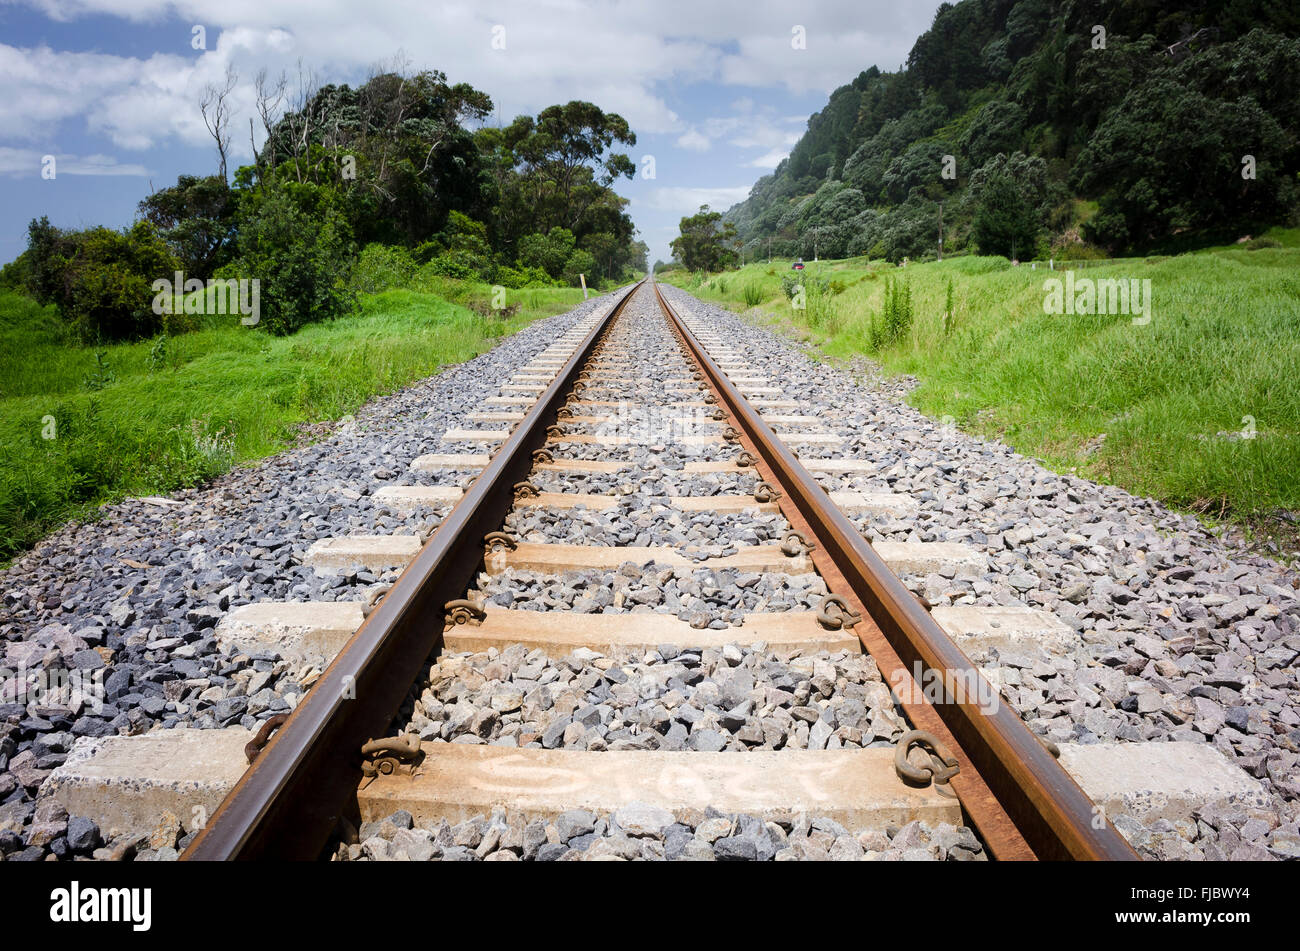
[403,644,906,752]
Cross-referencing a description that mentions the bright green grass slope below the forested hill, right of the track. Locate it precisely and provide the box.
[664,229,1300,524]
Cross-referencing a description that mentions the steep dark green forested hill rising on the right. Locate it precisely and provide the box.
[724,0,1300,261]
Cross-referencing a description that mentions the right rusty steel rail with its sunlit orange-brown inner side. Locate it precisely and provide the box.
[654,285,1138,860]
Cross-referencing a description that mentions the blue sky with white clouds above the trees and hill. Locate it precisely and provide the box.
[0,0,939,261]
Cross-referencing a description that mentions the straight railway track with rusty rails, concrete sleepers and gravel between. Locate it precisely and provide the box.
[165,283,1135,859]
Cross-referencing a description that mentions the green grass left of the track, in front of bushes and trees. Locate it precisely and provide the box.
[0,281,582,563]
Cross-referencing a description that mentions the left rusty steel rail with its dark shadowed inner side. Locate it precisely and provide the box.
[181,282,641,860]
